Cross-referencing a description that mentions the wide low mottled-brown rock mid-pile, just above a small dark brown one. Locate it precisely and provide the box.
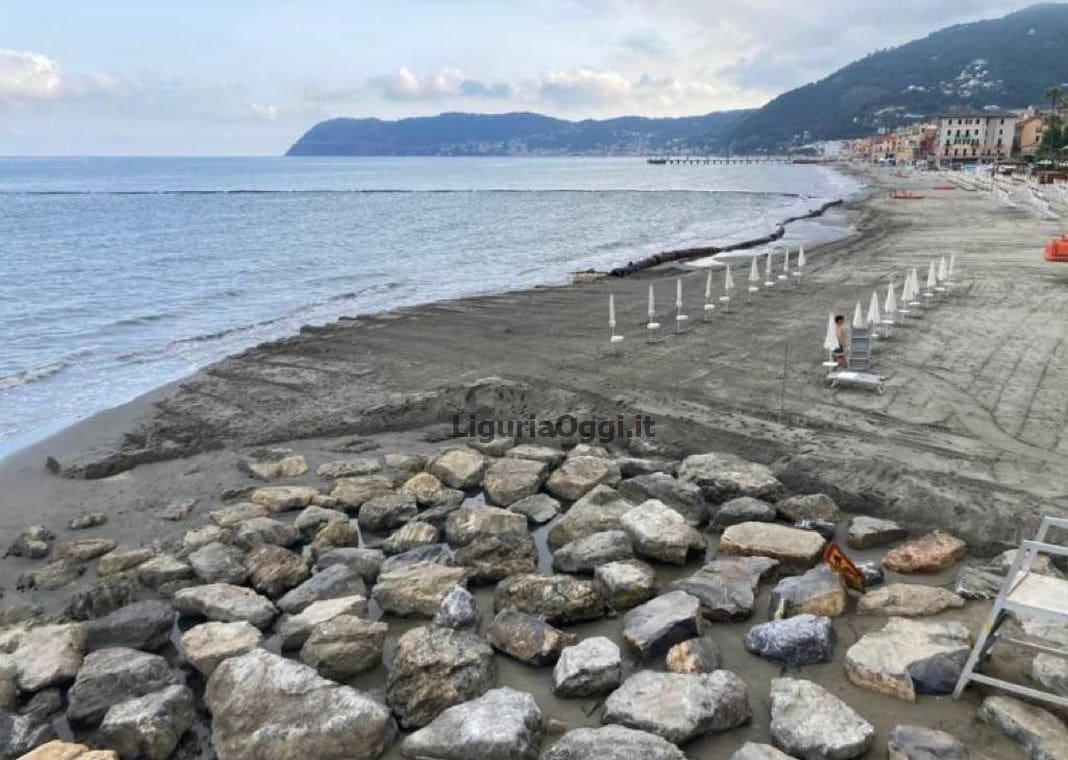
[493,574,604,624]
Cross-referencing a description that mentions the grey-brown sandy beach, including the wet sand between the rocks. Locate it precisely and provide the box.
[0,170,1068,759]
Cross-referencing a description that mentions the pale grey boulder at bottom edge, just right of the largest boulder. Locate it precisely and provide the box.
[401,687,543,760]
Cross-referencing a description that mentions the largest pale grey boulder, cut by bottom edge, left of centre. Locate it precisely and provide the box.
[204,649,396,760]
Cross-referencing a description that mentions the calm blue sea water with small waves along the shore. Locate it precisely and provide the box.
[0,158,859,456]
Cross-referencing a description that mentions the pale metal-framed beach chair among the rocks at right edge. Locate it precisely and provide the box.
[953,517,1068,708]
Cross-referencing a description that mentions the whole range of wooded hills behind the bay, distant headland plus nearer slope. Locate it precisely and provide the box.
[286,3,1068,156]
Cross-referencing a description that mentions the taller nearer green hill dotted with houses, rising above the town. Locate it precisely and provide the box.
[727,3,1068,152]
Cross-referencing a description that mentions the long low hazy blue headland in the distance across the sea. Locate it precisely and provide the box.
[285,111,751,156]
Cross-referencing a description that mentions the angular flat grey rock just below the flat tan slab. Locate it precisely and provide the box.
[671,555,779,622]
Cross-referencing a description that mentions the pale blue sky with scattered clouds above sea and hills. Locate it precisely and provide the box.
[0,0,1050,156]
